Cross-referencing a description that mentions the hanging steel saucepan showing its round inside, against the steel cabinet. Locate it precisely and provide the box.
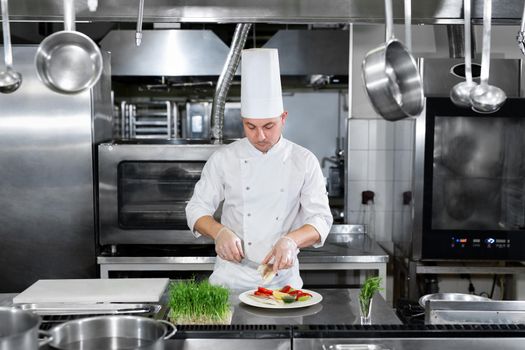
[35,0,102,94]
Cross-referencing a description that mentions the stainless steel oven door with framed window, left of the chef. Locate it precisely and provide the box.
[98,143,220,245]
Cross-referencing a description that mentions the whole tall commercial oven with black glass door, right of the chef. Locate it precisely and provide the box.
[394,59,525,262]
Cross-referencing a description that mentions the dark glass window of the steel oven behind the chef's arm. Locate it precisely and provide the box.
[118,161,205,230]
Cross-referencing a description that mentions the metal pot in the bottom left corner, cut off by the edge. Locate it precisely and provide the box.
[0,307,52,350]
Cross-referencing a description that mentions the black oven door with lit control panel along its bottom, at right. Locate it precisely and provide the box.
[415,98,525,260]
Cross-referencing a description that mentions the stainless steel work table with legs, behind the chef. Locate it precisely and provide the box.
[97,230,389,298]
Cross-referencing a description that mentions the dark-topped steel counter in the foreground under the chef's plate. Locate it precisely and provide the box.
[5,289,525,350]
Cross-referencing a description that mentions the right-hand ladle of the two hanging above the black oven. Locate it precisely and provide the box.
[470,0,507,113]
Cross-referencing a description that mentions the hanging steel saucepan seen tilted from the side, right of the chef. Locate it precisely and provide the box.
[363,0,423,121]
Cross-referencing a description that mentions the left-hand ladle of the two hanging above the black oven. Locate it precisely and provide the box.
[450,0,478,108]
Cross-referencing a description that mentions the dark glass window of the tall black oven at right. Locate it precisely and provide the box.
[431,116,525,231]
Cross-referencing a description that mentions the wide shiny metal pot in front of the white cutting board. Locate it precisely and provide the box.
[48,316,177,350]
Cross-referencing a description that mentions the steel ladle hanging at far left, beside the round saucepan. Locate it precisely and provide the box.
[0,0,22,94]
